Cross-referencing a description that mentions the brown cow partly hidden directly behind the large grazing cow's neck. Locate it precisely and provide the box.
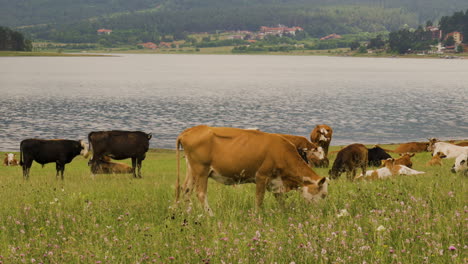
[277,134,328,168]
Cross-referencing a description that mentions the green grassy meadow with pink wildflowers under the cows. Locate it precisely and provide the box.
[0,145,468,263]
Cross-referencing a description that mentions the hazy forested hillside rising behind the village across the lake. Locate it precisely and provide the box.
[0,0,468,43]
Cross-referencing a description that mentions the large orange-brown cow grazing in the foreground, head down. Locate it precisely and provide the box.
[176,125,328,215]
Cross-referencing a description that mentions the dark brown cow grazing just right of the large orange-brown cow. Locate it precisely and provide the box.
[328,144,368,180]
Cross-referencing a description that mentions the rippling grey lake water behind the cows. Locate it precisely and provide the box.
[0,55,468,151]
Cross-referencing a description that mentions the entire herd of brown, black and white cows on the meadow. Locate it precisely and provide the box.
[3,125,468,214]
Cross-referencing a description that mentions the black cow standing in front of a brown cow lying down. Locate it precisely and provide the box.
[88,130,152,178]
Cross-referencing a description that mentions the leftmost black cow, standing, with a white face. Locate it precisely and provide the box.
[20,138,88,180]
